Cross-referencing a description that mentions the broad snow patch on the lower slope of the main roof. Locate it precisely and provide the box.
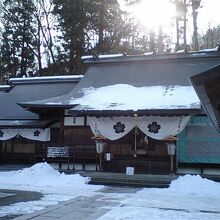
[70,84,201,110]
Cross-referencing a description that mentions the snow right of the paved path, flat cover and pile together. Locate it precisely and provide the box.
[99,175,220,220]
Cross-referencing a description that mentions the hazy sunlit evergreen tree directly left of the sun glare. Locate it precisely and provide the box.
[89,0,131,54]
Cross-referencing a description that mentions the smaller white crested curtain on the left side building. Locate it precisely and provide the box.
[0,128,50,141]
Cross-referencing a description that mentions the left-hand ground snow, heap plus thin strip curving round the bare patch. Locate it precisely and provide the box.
[0,163,103,217]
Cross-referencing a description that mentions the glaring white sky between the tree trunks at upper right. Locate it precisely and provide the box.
[119,0,220,41]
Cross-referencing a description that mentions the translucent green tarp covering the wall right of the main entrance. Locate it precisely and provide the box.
[177,116,220,163]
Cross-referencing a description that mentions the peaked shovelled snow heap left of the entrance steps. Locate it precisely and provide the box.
[0,163,100,194]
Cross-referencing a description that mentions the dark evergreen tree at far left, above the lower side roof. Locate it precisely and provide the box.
[1,0,36,77]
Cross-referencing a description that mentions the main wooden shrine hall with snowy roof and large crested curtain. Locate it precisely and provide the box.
[1,49,220,174]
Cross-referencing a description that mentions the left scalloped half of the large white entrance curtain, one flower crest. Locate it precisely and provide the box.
[88,117,135,140]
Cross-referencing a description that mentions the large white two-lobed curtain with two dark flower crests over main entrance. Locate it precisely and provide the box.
[88,116,190,140]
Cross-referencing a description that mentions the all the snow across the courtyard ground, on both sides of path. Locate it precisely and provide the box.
[0,163,220,220]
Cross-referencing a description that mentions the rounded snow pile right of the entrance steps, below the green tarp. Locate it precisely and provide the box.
[169,175,220,196]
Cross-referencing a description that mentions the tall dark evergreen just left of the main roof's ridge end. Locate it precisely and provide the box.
[53,0,89,73]
